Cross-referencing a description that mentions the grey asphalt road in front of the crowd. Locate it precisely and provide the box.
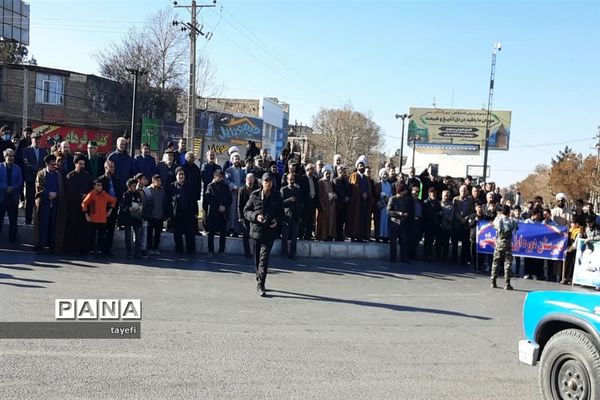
[0,251,584,400]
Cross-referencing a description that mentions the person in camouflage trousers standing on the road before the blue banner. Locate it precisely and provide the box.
[491,205,519,290]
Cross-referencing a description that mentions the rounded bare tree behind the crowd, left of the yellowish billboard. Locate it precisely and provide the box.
[312,104,382,164]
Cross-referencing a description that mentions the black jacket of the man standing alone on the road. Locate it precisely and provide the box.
[244,189,283,242]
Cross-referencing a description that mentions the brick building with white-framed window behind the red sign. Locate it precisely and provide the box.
[0,64,131,154]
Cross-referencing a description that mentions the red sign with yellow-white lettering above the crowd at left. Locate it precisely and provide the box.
[31,123,113,153]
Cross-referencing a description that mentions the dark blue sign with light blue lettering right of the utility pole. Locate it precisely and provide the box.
[196,111,263,156]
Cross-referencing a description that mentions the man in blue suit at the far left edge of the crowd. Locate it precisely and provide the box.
[0,149,23,239]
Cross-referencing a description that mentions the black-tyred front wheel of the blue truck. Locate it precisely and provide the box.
[539,329,600,400]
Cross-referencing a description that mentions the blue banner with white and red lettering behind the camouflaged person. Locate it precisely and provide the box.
[477,221,567,260]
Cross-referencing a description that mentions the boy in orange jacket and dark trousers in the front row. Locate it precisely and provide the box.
[81,179,117,257]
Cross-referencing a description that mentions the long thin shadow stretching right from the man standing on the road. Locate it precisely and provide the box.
[267,290,492,321]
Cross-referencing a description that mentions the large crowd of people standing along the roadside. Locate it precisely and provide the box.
[0,122,599,290]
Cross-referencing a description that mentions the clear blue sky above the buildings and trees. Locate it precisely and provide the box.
[25,0,600,185]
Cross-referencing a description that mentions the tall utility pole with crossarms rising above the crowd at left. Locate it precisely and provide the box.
[173,0,217,148]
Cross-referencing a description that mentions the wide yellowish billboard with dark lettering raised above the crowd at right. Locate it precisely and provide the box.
[408,108,511,150]
